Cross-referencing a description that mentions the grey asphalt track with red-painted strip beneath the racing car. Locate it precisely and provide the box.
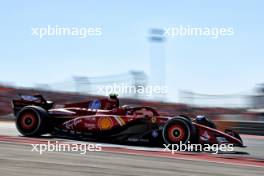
[0,122,264,176]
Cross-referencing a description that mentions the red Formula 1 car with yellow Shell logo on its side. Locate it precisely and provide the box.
[12,95,243,147]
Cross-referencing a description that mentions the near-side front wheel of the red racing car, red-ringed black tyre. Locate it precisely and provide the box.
[162,116,195,144]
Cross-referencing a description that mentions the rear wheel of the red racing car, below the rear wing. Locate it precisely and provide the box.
[16,106,48,137]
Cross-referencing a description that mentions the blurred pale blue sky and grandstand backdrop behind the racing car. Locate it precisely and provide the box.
[0,0,264,135]
